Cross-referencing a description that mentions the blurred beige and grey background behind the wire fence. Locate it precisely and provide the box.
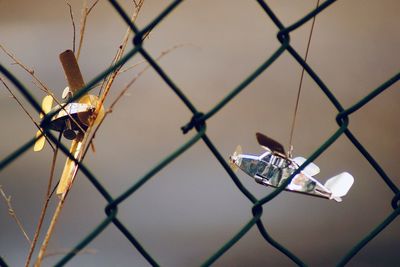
[0,0,400,266]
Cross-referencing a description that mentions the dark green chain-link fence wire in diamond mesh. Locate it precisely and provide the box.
[0,0,400,266]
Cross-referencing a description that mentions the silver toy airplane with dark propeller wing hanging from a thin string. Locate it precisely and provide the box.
[229,133,354,202]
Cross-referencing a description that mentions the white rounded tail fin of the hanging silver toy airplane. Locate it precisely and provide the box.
[325,172,354,202]
